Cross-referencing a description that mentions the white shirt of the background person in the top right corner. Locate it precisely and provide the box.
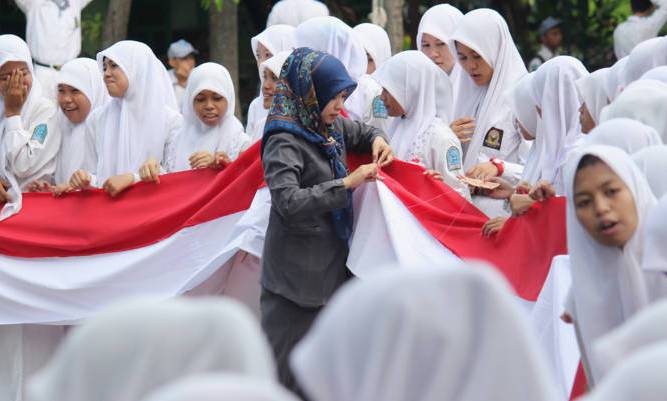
[614,0,667,60]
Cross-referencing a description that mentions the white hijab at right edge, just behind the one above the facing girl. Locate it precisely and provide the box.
[600,80,667,142]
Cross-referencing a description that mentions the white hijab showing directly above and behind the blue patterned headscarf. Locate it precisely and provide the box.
[296,17,371,121]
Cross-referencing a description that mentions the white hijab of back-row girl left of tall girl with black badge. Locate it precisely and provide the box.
[416,4,466,120]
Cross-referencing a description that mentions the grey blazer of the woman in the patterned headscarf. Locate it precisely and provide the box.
[262,117,386,307]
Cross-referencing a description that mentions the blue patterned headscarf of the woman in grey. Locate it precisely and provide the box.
[262,47,357,240]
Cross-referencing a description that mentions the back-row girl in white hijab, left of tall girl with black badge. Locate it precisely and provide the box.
[416,4,464,121]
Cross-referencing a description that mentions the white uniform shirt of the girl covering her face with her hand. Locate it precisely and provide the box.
[2,98,61,190]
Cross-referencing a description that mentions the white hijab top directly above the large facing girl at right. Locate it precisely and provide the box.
[585,118,662,155]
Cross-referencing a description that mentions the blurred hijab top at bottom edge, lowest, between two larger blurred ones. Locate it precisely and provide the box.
[143,373,298,401]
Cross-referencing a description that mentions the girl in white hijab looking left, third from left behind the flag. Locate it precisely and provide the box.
[70,40,182,196]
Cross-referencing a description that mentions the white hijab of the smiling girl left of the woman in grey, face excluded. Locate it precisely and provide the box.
[172,63,250,171]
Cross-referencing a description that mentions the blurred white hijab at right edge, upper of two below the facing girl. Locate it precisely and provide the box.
[593,301,667,378]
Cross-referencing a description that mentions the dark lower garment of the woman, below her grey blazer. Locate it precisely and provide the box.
[260,288,322,399]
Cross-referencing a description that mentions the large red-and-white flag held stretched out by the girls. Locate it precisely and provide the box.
[0,143,576,396]
